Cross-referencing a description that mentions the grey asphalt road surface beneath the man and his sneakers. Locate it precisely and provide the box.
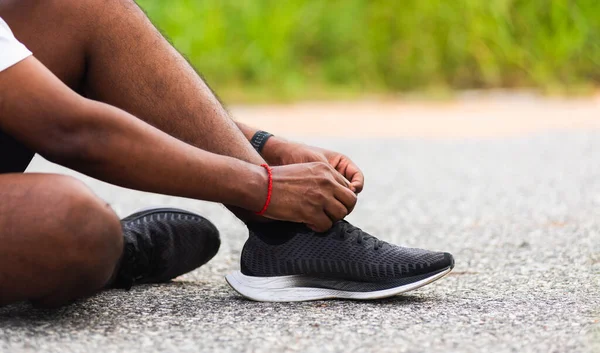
[0,131,600,353]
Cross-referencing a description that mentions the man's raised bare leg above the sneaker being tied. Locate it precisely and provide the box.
[0,0,265,220]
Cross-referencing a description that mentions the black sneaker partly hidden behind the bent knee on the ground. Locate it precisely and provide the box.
[113,208,221,289]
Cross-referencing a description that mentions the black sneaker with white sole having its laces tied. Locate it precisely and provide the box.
[226,221,454,302]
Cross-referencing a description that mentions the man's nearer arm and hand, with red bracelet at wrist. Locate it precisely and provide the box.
[0,57,356,230]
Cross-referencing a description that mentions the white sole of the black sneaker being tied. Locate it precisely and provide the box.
[225,267,452,302]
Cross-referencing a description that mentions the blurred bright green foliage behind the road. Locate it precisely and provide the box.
[138,0,600,100]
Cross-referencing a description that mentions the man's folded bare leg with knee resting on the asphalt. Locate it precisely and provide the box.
[0,174,123,307]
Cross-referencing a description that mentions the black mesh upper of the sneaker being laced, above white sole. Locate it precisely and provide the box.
[241,221,451,281]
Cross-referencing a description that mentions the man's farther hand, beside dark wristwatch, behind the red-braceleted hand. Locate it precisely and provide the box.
[262,136,365,194]
